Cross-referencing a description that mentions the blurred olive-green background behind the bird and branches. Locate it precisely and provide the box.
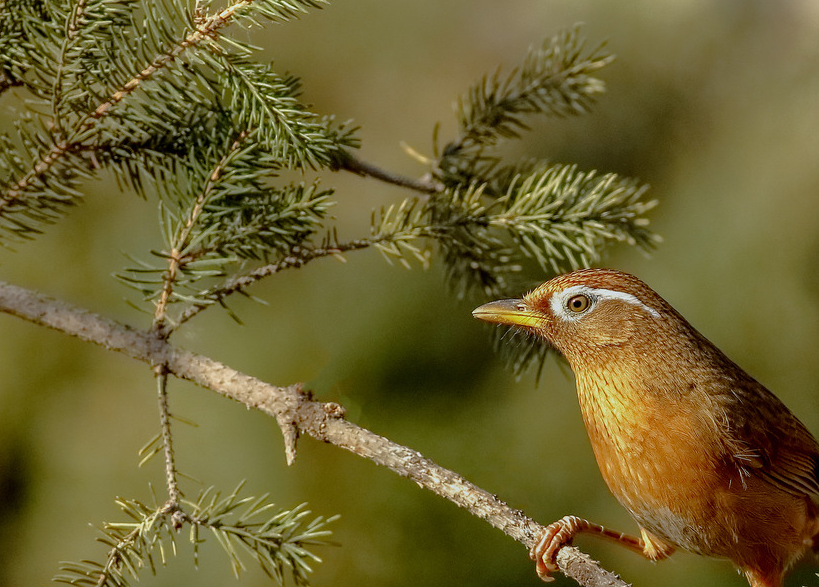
[0,0,819,587]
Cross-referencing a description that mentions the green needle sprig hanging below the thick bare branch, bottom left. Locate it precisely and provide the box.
[54,484,335,587]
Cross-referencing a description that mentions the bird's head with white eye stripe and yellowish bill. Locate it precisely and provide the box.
[472,269,681,364]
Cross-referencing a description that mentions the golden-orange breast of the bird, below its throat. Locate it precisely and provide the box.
[577,371,726,554]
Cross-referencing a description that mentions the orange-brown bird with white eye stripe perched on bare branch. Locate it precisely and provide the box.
[473,269,819,587]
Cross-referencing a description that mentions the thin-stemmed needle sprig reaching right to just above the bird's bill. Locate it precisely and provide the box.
[175,156,656,336]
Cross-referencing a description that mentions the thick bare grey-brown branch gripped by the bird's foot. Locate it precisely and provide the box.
[0,282,627,587]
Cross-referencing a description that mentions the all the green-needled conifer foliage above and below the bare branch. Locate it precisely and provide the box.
[0,0,655,586]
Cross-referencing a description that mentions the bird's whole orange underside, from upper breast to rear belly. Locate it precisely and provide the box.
[577,370,819,574]
